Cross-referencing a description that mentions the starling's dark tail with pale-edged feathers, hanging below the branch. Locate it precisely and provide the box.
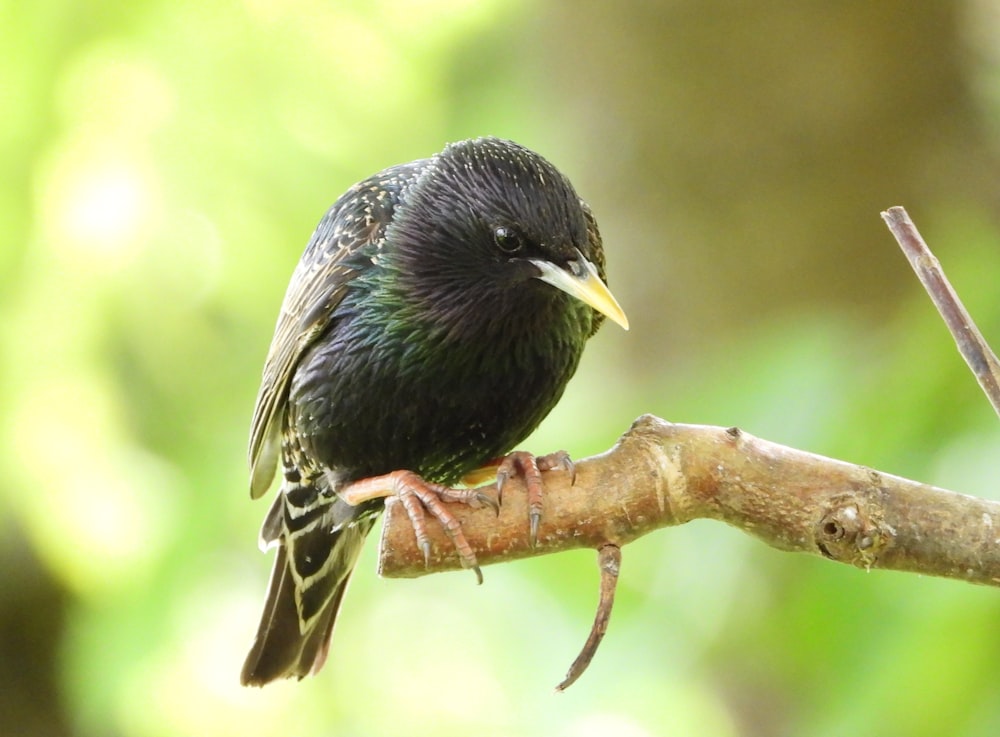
[240,487,377,686]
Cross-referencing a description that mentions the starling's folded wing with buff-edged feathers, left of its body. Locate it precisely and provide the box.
[248,161,426,499]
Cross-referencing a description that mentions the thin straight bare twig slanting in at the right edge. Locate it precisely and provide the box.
[882,207,1000,415]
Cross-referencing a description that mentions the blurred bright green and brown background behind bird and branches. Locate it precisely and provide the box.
[0,0,1000,737]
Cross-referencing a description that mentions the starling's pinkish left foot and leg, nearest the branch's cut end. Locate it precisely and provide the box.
[339,471,500,583]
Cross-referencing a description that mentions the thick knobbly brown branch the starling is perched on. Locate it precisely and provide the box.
[379,415,1000,586]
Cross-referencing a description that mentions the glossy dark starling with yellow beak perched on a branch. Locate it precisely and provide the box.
[241,137,628,686]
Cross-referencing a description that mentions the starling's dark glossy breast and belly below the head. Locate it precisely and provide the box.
[289,290,587,483]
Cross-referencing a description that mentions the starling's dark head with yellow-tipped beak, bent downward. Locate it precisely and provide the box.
[391,138,628,332]
